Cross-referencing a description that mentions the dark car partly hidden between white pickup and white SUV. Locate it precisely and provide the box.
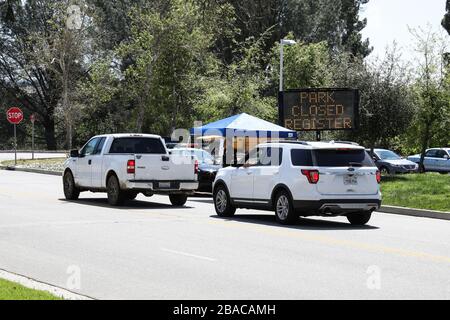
[171,148,222,192]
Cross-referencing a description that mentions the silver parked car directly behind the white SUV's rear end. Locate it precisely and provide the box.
[367,149,419,175]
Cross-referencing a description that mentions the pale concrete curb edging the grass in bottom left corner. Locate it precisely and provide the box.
[0,269,95,300]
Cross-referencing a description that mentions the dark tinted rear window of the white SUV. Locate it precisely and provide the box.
[313,149,375,167]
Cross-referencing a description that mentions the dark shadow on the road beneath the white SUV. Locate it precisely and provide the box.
[210,214,379,230]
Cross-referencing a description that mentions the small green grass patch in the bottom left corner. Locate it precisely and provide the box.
[0,279,62,300]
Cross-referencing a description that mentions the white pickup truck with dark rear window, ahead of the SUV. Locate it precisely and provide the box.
[63,134,198,206]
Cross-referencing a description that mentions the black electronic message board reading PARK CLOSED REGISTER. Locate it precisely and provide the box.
[279,88,359,140]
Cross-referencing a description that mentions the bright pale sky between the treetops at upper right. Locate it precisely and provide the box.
[360,0,448,61]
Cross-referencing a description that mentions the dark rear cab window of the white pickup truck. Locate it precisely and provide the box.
[109,138,166,154]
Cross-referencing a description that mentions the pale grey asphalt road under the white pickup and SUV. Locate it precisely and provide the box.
[0,171,450,299]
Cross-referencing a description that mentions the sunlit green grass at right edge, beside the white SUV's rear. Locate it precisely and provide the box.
[381,173,450,212]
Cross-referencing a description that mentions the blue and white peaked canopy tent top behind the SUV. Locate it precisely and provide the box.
[191,113,297,139]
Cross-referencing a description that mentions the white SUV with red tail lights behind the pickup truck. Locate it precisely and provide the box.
[213,141,381,225]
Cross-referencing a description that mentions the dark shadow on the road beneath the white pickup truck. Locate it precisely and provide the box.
[59,198,192,210]
